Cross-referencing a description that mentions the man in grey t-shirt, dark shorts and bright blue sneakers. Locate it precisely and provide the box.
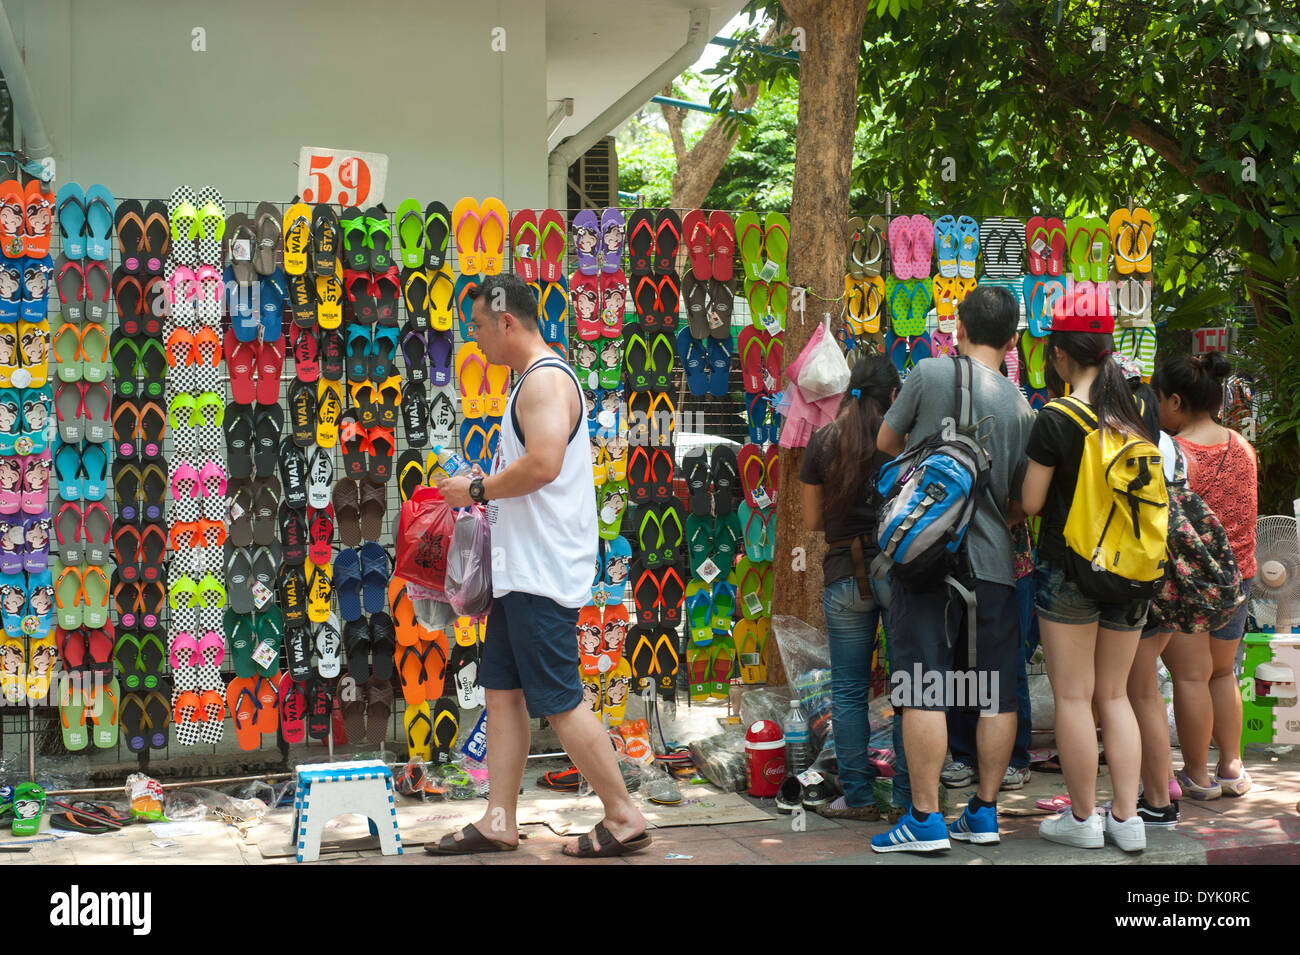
[871,286,1034,852]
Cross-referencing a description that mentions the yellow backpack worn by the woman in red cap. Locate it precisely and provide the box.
[1048,398,1169,603]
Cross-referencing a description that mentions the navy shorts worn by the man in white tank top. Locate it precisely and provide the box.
[478,592,582,719]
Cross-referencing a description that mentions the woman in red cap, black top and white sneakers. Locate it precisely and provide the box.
[1022,309,1154,851]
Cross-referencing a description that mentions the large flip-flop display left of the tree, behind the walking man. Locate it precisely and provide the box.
[15,183,784,759]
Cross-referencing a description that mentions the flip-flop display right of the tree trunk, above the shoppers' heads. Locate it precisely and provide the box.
[844,205,1156,408]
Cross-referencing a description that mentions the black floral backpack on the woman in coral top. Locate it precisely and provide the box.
[1147,442,1245,633]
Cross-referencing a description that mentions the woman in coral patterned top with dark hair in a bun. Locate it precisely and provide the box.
[1152,352,1258,799]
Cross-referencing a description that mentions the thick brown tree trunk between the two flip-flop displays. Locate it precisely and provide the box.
[767,0,867,685]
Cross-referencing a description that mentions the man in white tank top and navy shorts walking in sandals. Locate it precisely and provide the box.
[425,274,650,856]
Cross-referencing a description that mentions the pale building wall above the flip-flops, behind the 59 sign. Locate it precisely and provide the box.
[4,0,546,209]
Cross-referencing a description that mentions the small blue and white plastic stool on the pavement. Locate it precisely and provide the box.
[294,759,402,863]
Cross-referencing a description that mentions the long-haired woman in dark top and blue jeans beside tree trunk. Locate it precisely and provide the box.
[800,355,898,820]
